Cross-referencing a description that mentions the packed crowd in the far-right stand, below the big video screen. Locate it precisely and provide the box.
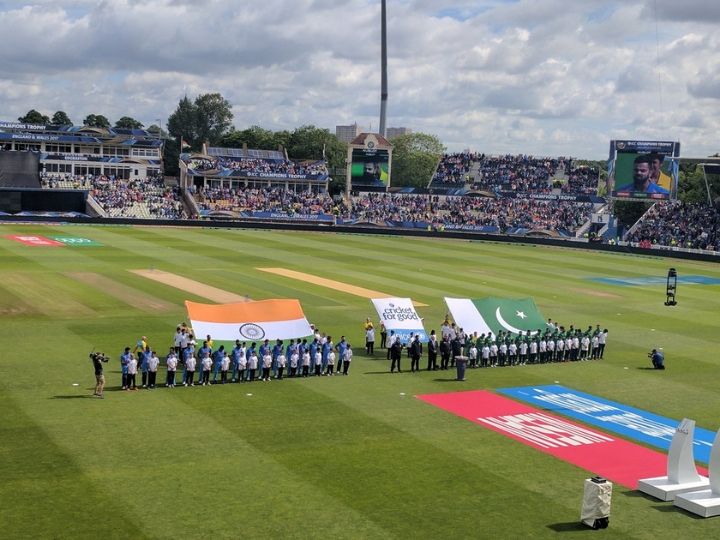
[625,201,720,251]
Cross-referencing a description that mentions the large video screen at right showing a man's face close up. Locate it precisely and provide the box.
[608,141,680,199]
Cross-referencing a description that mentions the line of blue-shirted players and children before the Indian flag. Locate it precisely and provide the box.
[120,333,353,390]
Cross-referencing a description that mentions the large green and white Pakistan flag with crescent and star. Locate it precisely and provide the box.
[445,296,546,335]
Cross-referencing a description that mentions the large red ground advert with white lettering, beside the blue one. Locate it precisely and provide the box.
[418,390,696,489]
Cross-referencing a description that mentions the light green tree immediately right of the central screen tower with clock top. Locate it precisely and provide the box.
[390,132,445,187]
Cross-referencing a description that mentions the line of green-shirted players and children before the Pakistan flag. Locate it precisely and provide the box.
[450,326,608,367]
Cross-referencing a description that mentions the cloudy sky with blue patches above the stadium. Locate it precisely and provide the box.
[0,0,720,159]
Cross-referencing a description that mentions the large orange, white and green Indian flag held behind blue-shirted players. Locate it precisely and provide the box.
[185,299,313,341]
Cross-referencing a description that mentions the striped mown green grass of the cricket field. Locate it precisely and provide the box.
[0,221,720,538]
